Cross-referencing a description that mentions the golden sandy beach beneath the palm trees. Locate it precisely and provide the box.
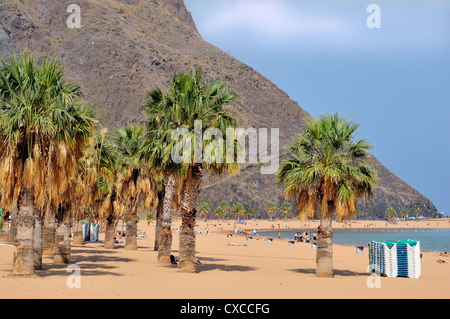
[0,220,450,299]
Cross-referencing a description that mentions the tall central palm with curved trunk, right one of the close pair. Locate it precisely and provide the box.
[174,70,239,272]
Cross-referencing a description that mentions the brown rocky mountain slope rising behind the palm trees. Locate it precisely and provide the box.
[0,0,436,217]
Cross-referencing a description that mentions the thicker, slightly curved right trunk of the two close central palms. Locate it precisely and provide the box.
[178,165,202,272]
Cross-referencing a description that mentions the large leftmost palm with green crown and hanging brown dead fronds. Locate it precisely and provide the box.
[0,55,94,275]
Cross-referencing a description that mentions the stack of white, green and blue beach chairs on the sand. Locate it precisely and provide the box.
[369,239,421,279]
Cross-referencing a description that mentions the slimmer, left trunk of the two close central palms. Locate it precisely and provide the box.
[158,175,177,264]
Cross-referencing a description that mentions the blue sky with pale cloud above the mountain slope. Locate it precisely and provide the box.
[185,0,450,215]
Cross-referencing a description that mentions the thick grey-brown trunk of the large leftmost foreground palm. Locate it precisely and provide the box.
[13,186,36,276]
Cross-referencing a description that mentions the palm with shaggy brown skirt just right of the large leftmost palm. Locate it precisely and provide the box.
[47,88,96,264]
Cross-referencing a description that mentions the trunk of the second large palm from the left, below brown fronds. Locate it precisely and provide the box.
[53,205,71,264]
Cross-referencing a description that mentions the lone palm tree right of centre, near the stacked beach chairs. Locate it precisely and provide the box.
[277,114,378,277]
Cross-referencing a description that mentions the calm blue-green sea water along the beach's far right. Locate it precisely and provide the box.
[259,229,450,253]
